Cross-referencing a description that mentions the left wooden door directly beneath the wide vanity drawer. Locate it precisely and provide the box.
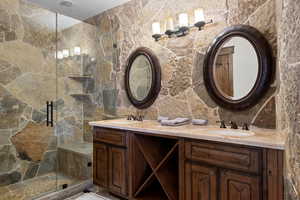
[185,163,217,200]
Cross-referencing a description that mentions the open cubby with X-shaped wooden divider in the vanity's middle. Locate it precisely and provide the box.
[132,134,179,200]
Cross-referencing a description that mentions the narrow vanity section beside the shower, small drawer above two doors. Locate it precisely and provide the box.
[93,129,128,197]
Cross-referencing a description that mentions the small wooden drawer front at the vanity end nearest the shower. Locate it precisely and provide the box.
[94,128,126,146]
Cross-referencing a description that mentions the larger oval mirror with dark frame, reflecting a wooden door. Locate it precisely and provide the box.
[203,25,273,110]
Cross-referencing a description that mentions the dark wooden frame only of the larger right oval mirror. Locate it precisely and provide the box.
[203,25,275,111]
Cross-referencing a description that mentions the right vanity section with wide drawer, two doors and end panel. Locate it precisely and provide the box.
[184,140,283,200]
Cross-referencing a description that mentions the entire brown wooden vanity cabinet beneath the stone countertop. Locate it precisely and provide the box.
[94,128,283,200]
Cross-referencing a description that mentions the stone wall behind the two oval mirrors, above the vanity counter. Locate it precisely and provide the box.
[87,0,277,128]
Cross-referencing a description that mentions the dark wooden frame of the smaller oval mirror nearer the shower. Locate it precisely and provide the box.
[125,47,161,109]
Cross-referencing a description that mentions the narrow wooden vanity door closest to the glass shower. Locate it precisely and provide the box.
[93,143,108,188]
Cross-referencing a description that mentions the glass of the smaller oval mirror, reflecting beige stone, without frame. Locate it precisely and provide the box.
[129,55,152,101]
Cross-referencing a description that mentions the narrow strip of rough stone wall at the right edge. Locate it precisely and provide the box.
[277,0,300,200]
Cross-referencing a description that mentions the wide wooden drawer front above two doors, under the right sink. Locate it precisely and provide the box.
[185,141,262,173]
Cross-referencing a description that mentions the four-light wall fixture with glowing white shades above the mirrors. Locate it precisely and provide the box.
[152,8,213,41]
